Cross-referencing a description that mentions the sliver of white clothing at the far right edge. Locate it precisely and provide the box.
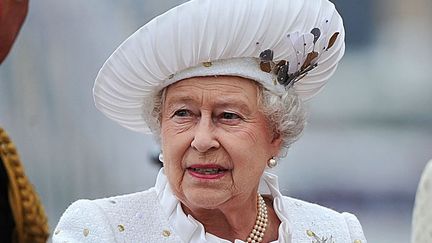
[411,160,432,243]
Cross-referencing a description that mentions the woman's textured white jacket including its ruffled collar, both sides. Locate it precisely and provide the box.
[53,169,366,243]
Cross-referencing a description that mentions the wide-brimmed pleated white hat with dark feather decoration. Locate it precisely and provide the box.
[93,0,345,133]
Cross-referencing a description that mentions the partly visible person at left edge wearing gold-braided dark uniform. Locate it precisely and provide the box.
[0,0,49,243]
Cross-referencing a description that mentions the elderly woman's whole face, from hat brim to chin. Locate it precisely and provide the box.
[161,76,281,209]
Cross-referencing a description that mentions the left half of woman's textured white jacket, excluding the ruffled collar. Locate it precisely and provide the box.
[52,188,183,243]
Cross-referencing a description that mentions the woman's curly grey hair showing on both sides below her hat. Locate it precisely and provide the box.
[144,83,306,158]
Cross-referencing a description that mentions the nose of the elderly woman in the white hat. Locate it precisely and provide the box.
[191,117,220,153]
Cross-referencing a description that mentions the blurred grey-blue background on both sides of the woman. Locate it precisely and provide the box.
[0,0,432,243]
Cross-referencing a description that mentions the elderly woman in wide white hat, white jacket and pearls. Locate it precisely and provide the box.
[53,0,366,243]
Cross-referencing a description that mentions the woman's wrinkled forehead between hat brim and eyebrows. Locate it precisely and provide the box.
[166,76,259,104]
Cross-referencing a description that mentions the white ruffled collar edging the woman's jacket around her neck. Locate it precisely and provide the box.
[155,168,291,243]
